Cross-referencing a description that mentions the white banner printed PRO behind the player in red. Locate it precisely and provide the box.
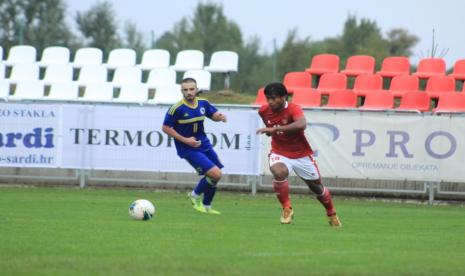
[305,110,465,182]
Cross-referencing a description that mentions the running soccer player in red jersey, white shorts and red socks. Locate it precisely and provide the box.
[257,83,342,227]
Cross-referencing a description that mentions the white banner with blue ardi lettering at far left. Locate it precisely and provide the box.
[0,104,60,167]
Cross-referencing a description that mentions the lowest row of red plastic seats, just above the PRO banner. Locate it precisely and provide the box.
[252,88,465,113]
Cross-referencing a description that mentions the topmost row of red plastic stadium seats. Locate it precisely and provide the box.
[305,54,465,80]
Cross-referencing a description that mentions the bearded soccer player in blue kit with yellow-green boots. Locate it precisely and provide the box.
[162,78,226,214]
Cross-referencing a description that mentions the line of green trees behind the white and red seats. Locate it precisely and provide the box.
[0,0,418,93]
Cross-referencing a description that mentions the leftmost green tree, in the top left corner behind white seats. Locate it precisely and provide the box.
[0,0,73,53]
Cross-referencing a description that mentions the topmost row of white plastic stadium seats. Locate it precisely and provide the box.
[0,45,239,73]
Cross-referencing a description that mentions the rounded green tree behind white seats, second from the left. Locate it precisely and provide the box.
[76,1,122,58]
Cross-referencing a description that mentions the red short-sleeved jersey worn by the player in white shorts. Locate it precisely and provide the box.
[258,102,313,159]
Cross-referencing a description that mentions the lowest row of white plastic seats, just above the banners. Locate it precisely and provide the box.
[0,80,182,104]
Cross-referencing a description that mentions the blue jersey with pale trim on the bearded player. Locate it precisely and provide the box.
[163,98,218,158]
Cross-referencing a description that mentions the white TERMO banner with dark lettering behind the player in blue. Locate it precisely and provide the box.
[61,105,260,175]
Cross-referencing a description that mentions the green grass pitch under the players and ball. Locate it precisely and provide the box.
[0,187,465,275]
